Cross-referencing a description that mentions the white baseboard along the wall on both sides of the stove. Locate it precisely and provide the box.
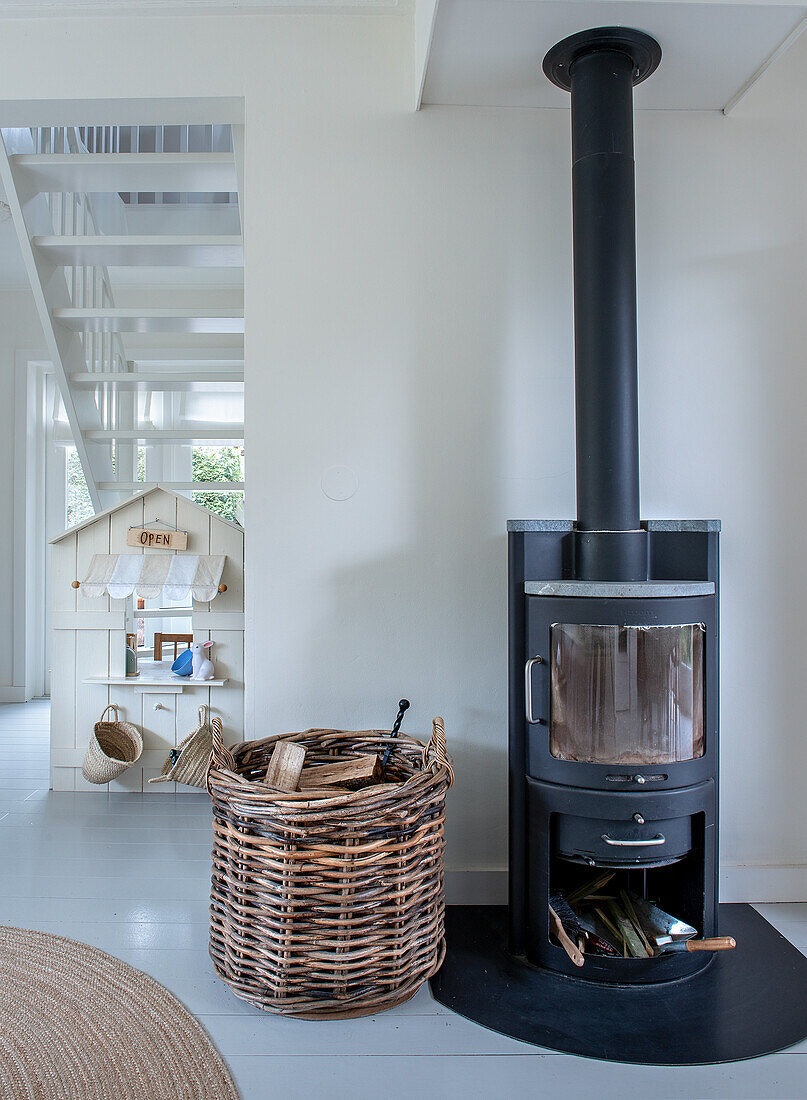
[445,864,807,905]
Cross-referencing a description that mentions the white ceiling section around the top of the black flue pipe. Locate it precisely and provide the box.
[423,0,807,110]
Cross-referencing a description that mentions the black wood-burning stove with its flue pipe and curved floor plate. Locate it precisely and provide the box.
[432,21,807,1065]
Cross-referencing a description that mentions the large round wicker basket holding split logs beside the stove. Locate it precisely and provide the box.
[208,718,454,1020]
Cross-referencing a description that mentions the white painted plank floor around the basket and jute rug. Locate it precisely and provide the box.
[0,703,807,1100]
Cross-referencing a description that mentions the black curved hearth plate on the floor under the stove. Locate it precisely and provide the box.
[431,905,807,1066]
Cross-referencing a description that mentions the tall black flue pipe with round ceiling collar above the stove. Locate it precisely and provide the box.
[543,28,661,580]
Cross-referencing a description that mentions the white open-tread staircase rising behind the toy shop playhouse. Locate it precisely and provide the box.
[0,125,244,510]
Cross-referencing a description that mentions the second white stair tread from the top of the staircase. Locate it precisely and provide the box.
[33,234,244,267]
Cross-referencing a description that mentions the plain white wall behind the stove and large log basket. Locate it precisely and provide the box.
[0,12,807,898]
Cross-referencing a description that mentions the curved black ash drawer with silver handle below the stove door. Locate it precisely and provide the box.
[552,814,693,867]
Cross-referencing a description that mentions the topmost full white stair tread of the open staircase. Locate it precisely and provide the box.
[9,153,239,191]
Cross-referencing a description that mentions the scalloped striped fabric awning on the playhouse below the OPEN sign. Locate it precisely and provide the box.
[81,553,226,603]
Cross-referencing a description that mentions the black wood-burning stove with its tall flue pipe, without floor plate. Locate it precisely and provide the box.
[508,28,719,982]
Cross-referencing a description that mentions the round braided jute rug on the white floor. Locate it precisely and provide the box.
[0,926,239,1100]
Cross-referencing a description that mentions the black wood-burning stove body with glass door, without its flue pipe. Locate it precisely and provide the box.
[508,521,718,982]
